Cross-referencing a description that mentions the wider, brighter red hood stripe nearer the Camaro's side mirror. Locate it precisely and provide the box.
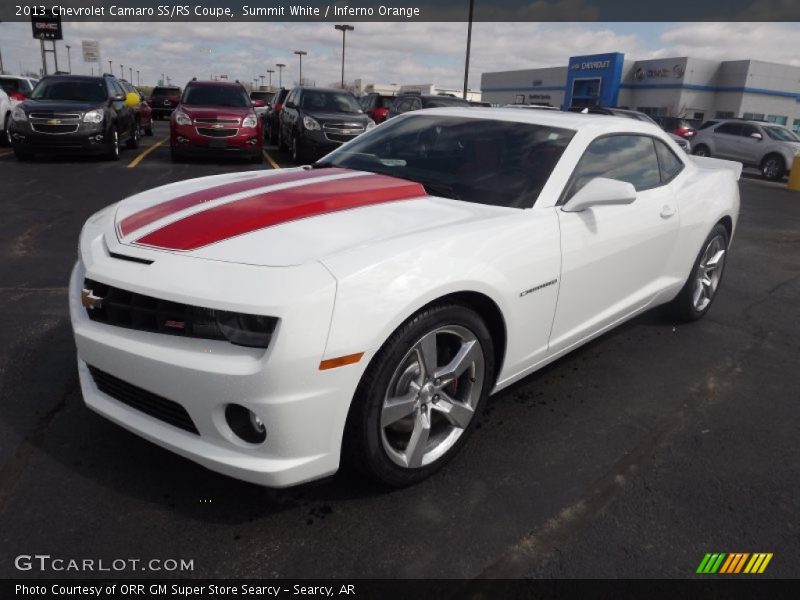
[135,175,426,250]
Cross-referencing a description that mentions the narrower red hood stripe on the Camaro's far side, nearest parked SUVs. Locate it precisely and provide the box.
[119,169,348,237]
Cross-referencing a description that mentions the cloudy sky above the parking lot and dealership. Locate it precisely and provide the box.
[0,22,800,89]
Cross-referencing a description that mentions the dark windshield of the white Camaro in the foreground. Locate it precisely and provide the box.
[321,113,575,208]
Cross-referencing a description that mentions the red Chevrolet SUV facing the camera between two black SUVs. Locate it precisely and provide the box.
[169,80,264,162]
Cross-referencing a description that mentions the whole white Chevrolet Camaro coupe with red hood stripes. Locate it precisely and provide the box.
[70,108,741,487]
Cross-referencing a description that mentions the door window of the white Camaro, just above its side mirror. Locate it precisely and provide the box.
[567,135,661,198]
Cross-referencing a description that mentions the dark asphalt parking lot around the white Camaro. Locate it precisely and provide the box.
[0,123,800,578]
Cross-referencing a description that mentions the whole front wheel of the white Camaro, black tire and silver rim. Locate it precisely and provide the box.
[343,303,495,487]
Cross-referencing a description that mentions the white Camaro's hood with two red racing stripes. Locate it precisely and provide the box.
[104,168,508,266]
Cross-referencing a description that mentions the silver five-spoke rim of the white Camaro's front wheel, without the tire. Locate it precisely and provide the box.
[380,325,485,469]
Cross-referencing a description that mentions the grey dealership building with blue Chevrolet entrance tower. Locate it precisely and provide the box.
[481,52,800,131]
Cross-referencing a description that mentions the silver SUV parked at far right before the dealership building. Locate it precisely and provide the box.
[692,119,800,180]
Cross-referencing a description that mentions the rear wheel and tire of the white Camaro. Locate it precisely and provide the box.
[666,223,729,322]
